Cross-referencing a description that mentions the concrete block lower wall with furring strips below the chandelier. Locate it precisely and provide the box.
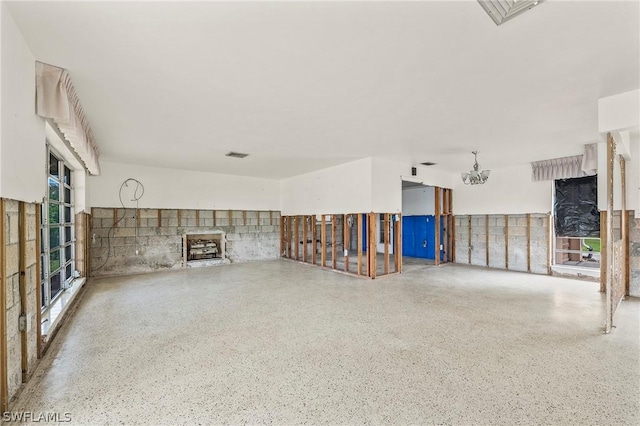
[454,213,550,274]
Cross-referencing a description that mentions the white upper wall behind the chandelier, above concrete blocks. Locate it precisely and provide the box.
[453,164,553,215]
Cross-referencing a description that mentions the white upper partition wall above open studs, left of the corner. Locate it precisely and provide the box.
[281,158,375,215]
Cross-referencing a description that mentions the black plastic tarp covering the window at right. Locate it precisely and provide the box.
[554,176,600,238]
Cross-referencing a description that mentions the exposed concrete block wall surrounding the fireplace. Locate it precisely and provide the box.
[89,208,280,276]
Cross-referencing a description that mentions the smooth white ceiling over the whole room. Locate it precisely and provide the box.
[7,0,640,178]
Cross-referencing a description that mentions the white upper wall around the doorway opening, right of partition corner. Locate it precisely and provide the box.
[371,158,455,213]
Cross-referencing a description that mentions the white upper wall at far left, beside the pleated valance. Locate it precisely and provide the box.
[0,3,46,203]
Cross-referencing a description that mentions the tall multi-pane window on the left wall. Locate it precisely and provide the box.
[40,149,75,310]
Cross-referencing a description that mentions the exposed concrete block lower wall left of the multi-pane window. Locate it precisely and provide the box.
[2,200,40,399]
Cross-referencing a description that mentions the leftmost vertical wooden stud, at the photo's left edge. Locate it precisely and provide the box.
[0,198,7,413]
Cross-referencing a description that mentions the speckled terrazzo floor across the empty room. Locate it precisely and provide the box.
[12,261,640,425]
